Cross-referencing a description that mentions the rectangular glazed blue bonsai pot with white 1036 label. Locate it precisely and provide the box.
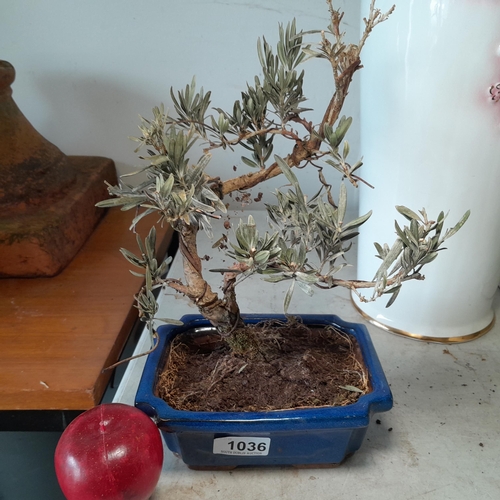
[135,315,392,469]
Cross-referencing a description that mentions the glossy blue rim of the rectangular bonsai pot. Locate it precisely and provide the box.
[135,314,392,427]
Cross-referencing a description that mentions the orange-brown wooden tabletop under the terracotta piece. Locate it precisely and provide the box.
[0,209,172,430]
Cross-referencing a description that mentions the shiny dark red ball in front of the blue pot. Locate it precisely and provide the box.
[55,403,163,500]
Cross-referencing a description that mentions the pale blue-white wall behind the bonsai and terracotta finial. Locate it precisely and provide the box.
[0,0,359,205]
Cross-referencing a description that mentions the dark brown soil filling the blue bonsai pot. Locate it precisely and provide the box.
[158,323,370,411]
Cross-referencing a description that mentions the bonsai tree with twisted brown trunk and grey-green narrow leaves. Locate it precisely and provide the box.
[99,0,468,344]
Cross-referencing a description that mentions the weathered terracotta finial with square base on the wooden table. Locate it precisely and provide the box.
[0,61,116,278]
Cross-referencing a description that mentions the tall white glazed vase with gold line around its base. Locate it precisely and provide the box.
[353,0,500,342]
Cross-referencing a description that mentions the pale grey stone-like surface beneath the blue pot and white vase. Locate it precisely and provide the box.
[115,213,500,500]
